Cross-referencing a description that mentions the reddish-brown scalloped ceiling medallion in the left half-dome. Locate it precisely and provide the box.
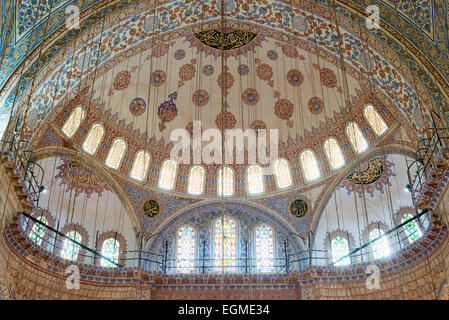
[55,158,109,198]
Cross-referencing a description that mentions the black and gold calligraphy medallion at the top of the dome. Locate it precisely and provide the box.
[187,27,264,56]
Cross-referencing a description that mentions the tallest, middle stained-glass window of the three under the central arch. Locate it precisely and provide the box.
[214,217,237,272]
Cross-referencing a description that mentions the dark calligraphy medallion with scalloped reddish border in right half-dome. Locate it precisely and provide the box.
[340,158,395,197]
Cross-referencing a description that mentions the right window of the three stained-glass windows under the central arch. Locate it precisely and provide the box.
[256,224,274,272]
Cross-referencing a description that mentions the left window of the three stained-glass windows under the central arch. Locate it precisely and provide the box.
[176,226,195,273]
